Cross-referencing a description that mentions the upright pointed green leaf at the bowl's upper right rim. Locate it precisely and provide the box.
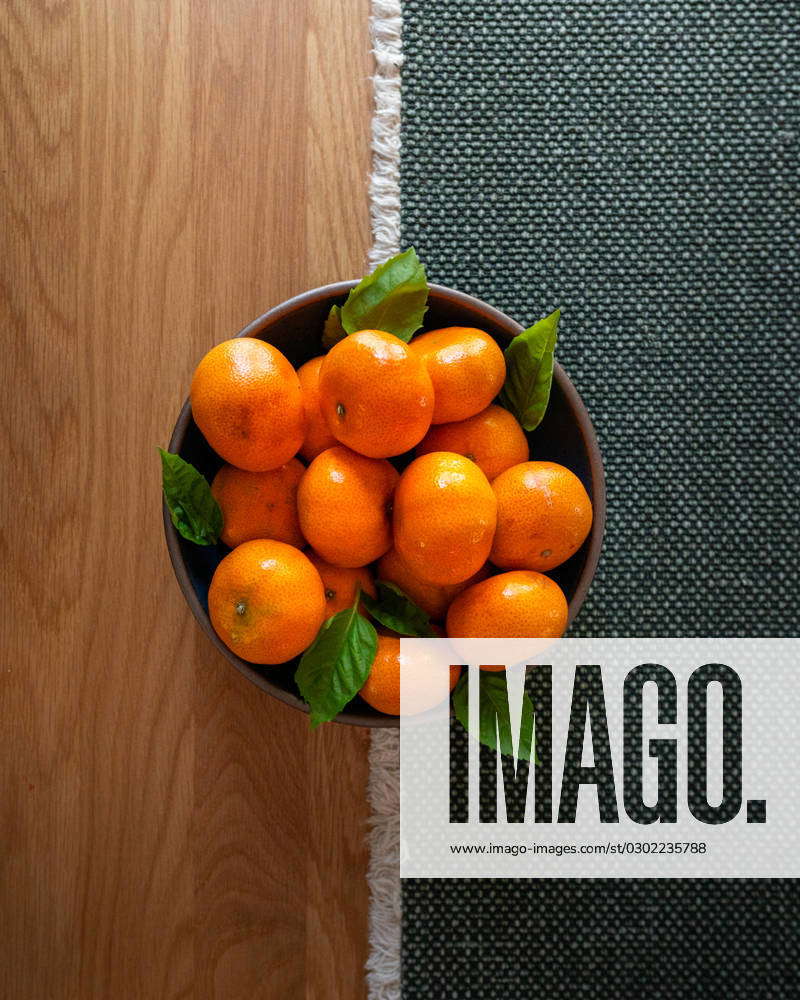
[500,309,561,431]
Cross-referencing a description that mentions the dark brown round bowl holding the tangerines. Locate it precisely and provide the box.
[164,281,606,726]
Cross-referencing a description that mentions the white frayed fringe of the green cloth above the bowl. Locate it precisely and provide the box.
[369,0,403,269]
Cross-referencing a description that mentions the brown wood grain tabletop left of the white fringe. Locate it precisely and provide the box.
[0,0,371,1000]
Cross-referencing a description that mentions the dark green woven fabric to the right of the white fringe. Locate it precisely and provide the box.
[401,0,800,1000]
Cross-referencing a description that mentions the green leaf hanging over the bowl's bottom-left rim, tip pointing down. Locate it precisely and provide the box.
[294,591,378,729]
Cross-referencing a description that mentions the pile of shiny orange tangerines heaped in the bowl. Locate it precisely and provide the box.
[186,327,592,714]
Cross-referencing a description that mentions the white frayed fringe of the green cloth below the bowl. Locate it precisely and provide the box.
[367,729,401,1000]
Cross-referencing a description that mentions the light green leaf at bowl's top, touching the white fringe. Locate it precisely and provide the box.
[338,247,428,342]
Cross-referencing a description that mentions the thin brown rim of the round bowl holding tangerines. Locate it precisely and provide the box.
[166,279,606,729]
